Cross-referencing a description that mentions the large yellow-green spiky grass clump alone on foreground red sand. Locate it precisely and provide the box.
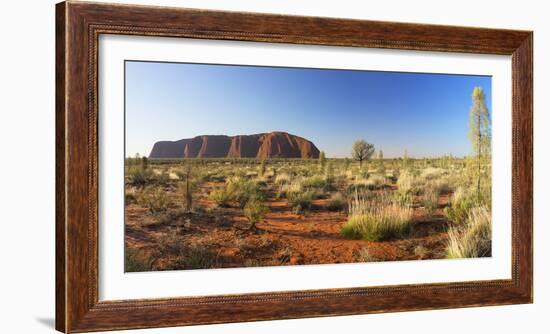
[341,193,412,241]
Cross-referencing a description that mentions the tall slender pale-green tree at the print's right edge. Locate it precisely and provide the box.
[468,87,491,193]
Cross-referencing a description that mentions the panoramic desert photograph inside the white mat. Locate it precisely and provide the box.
[121,60,493,272]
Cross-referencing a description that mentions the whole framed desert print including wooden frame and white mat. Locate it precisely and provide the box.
[56,1,533,332]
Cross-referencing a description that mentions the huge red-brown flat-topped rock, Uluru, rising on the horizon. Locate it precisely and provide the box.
[149,131,319,159]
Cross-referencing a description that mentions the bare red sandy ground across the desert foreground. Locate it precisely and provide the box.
[126,184,449,270]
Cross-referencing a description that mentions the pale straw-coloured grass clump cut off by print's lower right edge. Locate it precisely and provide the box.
[447,206,491,258]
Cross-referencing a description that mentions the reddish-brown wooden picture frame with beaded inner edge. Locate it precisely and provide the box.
[56,1,533,333]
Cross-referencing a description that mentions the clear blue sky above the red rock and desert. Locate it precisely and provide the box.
[126,61,492,158]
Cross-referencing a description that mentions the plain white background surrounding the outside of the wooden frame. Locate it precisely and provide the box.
[0,0,550,333]
